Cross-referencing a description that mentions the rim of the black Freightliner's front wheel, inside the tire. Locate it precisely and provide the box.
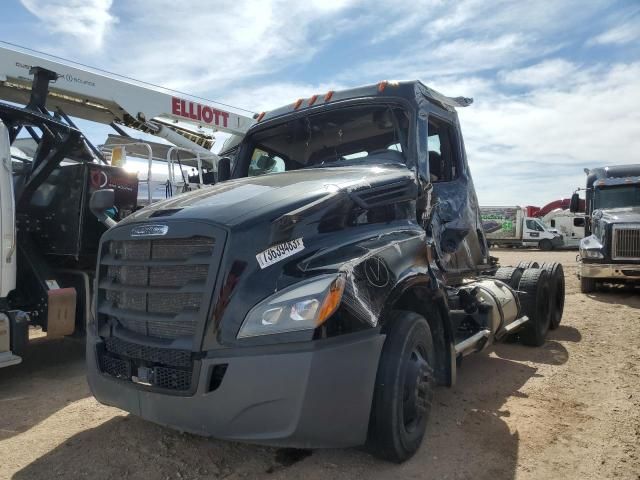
[402,345,431,433]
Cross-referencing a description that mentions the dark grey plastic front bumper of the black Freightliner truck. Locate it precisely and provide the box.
[87,332,385,448]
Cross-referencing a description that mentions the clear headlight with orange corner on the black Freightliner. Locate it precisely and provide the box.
[238,274,345,338]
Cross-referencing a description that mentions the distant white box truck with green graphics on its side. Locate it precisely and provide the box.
[480,206,563,251]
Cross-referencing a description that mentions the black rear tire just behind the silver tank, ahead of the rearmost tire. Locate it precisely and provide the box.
[518,268,551,347]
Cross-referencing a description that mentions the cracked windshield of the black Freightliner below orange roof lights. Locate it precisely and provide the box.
[238,105,410,176]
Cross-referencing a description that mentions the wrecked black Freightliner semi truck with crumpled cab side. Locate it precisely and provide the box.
[87,81,564,462]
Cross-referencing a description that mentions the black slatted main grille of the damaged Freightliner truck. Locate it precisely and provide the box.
[99,236,215,339]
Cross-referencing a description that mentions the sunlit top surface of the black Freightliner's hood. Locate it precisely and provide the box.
[121,165,413,226]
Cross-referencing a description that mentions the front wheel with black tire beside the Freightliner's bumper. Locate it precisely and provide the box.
[367,310,435,463]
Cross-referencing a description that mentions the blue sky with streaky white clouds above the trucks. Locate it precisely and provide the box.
[0,0,640,205]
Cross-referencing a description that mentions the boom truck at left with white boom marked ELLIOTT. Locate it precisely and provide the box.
[0,46,255,368]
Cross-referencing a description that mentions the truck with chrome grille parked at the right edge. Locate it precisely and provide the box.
[571,164,640,293]
